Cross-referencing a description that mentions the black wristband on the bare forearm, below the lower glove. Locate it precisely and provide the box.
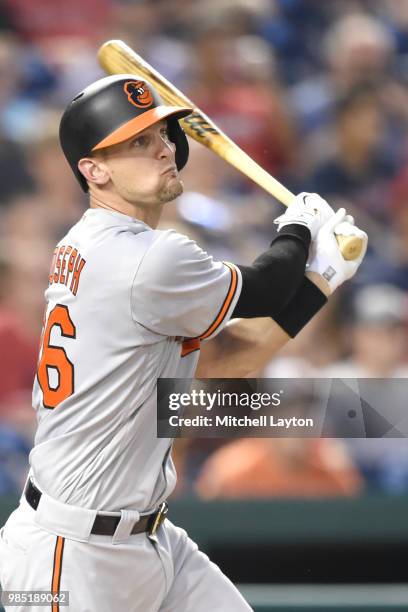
[274,276,327,338]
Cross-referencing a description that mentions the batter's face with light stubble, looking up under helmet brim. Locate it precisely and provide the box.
[97,121,183,206]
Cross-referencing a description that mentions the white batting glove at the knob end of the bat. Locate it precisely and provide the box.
[306,208,367,293]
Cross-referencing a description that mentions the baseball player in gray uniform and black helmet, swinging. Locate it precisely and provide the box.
[0,75,367,612]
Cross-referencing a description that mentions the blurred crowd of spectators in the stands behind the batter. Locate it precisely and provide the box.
[0,0,408,499]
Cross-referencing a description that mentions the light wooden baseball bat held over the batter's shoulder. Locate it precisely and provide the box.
[98,40,362,260]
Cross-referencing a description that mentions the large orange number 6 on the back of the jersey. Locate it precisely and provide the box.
[37,304,76,408]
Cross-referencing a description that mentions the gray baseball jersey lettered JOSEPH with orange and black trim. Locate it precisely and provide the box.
[30,209,242,512]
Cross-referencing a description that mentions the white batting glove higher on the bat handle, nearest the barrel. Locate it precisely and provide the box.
[274,192,334,240]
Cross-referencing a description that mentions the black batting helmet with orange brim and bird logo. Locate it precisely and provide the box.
[59,74,193,191]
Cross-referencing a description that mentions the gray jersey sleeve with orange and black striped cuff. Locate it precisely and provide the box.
[131,230,242,340]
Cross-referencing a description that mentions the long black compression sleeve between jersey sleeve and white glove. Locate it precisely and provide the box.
[232,224,310,319]
